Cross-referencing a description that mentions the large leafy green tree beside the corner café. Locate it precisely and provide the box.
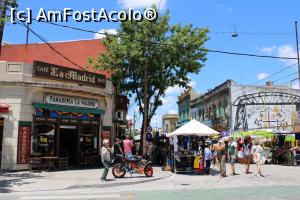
[93,8,208,154]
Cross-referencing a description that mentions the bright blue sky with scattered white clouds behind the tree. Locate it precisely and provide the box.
[4,0,300,127]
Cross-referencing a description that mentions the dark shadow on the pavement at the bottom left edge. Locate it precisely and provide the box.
[0,172,43,193]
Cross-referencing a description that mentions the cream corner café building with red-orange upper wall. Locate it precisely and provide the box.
[0,40,115,170]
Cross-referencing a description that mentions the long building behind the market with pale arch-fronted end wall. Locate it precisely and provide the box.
[190,80,300,136]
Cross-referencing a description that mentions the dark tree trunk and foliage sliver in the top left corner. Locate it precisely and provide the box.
[0,0,18,55]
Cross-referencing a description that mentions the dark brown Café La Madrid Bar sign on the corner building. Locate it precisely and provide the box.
[33,61,106,88]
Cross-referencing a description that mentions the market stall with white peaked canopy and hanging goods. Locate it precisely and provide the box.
[168,120,220,173]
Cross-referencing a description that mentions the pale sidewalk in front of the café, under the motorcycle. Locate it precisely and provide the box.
[0,167,172,192]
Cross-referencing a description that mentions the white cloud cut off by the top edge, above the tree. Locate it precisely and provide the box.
[118,0,167,9]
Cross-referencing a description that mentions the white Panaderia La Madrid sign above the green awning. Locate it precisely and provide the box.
[45,94,99,108]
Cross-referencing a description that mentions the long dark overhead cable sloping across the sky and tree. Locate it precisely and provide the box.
[29,20,297,60]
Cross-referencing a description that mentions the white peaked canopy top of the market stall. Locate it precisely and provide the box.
[168,119,220,137]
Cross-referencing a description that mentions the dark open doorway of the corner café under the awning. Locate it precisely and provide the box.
[59,125,78,166]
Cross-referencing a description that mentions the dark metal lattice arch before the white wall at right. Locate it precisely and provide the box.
[233,92,300,130]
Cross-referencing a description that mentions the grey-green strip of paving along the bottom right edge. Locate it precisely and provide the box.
[132,185,300,200]
